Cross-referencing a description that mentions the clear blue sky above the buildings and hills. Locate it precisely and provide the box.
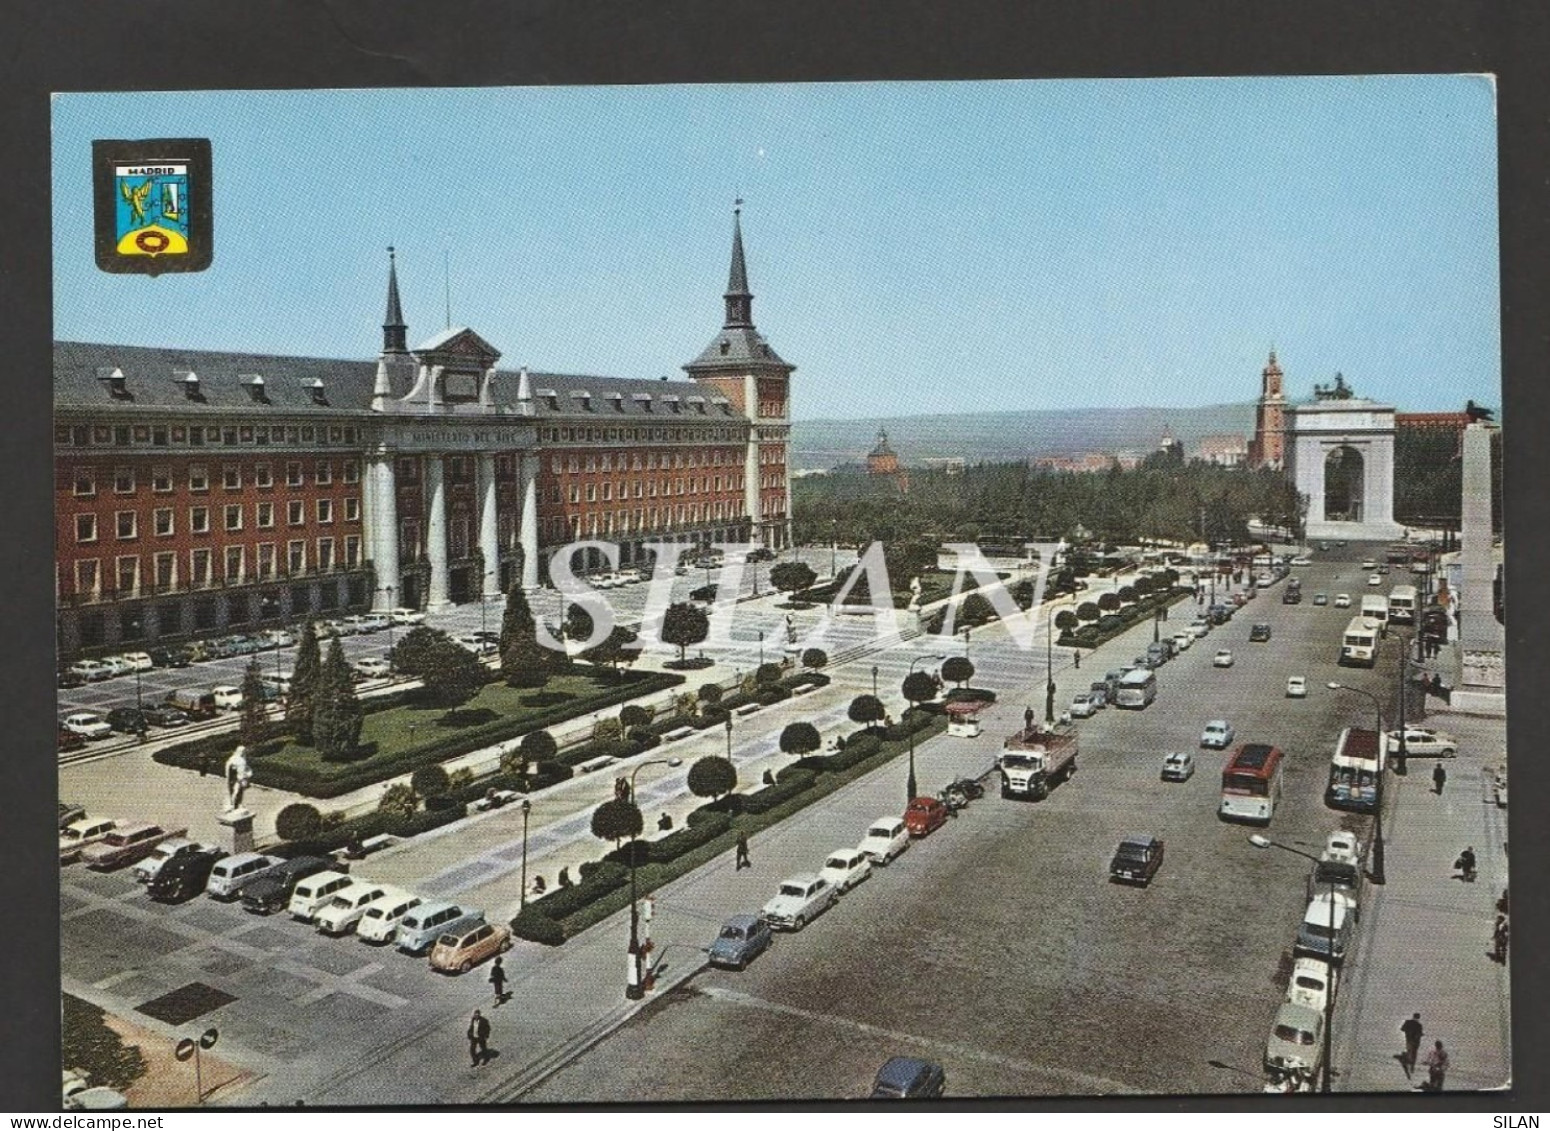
[53,76,1500,418]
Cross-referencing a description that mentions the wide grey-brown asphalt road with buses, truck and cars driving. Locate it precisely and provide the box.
[525,556,1392,1102]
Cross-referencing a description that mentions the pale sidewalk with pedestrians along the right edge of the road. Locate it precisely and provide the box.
[1331,629,1511,1092]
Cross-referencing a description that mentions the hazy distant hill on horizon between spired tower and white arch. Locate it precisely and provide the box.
[791,403,1254,469]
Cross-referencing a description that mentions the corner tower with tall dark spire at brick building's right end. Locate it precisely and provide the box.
[684,200,797,547]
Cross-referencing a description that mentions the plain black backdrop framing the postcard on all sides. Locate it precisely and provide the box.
[0,0,1550,1112]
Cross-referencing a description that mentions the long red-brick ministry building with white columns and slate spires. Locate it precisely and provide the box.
[54,214,794,655]
